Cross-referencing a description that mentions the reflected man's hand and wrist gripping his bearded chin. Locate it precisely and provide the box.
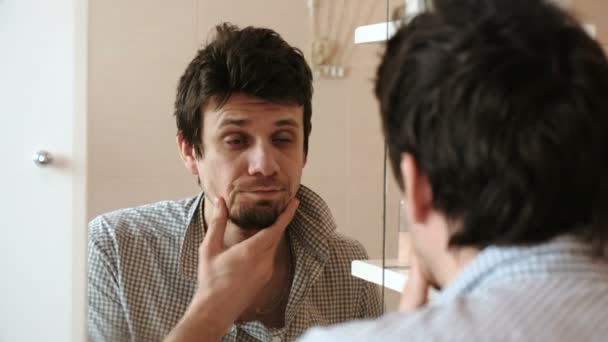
[166,198,299,342]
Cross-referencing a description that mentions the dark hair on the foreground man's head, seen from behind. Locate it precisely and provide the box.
[376,0,608,255]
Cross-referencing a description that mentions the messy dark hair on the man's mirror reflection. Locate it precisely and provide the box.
[174,23,313,156]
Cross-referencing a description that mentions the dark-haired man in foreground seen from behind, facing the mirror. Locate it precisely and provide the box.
[303,0,608,342]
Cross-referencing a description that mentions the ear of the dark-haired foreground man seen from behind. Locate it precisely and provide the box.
[401,153,433,224]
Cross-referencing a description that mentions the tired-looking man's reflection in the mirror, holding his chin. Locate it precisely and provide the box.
[88,24,381,341]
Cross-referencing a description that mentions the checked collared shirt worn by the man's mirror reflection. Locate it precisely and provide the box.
[88,186,382,341]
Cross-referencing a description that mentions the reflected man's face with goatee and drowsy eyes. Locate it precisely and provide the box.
[197,95,305,229]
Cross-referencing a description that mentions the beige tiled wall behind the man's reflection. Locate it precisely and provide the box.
[89,0,398,257]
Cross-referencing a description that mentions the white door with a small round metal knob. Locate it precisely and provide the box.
[0,0,87,342]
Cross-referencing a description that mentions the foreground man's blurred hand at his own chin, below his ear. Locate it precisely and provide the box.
[399,252,430,312]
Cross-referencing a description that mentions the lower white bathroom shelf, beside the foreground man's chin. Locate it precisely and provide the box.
[351,259,408,292]
